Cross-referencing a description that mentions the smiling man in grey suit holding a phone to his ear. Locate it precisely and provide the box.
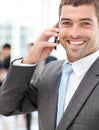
[0,0,99,130]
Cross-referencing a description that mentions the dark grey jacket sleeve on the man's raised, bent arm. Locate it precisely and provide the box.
[0,60,37,116]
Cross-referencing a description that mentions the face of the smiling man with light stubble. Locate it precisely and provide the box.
[59,5,99,62]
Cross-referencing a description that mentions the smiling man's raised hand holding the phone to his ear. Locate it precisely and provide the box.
[22,24,59,64]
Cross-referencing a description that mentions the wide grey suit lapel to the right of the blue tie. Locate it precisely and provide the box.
[57,58,99,130]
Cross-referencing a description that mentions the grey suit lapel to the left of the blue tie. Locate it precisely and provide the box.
[49,62,63,130]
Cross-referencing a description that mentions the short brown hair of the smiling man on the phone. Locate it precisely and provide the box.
[59,0,99,22]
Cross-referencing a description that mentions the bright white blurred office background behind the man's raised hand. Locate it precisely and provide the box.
[0,0,64,60]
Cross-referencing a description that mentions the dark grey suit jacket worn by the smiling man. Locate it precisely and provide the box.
[0,58,99,130]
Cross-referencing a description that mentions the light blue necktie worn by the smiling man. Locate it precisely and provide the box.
[56,63,73,126]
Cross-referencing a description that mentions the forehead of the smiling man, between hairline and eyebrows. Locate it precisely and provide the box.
[60,5,97,19]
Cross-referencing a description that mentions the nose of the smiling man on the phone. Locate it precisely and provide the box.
[70,25,81,39]
